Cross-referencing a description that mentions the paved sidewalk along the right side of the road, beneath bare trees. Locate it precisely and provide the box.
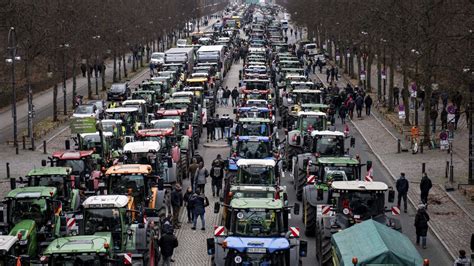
[314,57,474,257]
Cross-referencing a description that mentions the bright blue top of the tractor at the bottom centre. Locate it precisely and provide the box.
[225,236,290,253]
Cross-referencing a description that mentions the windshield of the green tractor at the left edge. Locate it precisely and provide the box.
[9,198,49,226]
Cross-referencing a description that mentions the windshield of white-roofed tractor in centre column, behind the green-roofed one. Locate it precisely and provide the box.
[237,165,275,186]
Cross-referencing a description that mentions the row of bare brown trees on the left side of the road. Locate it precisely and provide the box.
[0,0,225,110]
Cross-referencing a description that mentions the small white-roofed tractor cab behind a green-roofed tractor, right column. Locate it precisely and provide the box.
[311,130,345,157]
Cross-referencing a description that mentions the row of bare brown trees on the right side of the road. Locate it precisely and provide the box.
[277,0,474,141]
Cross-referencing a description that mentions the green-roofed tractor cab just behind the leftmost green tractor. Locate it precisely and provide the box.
[23,166,80,211]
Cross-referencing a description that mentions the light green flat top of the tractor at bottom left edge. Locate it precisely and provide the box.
[44,233,112,255]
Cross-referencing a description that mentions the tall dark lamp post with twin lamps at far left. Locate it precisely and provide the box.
[5,27,21,154]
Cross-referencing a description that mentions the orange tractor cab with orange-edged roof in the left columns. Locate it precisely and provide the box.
[105,164,162,216]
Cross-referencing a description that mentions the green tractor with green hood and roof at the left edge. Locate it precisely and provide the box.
[0,186,63,260]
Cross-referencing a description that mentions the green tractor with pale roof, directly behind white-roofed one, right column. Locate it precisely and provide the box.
[285,112,328,171]
